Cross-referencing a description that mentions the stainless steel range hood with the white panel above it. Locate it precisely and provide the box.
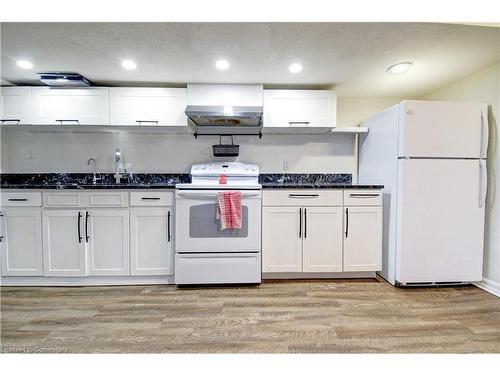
[185,84,264,135]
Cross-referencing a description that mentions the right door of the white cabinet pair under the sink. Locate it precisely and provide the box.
[84,209,130,276]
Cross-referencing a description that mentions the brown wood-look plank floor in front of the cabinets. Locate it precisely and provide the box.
[0,280,500,353]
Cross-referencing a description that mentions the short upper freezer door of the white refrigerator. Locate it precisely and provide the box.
[399,100,488,158]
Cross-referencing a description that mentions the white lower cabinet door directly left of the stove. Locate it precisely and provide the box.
[130,208,173,275]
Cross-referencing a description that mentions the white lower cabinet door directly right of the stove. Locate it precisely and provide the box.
[262,207,302,272]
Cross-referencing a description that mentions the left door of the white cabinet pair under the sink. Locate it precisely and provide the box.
[42,210,87,276]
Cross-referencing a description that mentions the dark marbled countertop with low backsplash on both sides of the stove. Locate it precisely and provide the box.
[0,173,383,190]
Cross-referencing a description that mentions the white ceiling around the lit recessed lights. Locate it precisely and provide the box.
[1,23,500,97]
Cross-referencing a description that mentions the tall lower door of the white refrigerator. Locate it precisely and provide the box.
[396,159,486,283]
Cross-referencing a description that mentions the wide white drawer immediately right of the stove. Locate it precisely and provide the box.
[262,189,342,206]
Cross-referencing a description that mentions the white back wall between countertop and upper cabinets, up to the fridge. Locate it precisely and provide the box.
[1,98,399,178]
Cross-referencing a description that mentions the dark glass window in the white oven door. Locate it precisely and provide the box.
[189,203,248,238]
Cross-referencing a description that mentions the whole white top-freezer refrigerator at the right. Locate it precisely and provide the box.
[358,100,488,286]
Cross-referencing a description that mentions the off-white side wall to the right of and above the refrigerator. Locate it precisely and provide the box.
[423,64,500,295]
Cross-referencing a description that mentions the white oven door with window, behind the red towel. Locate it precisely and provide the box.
[175,190,261,253]
